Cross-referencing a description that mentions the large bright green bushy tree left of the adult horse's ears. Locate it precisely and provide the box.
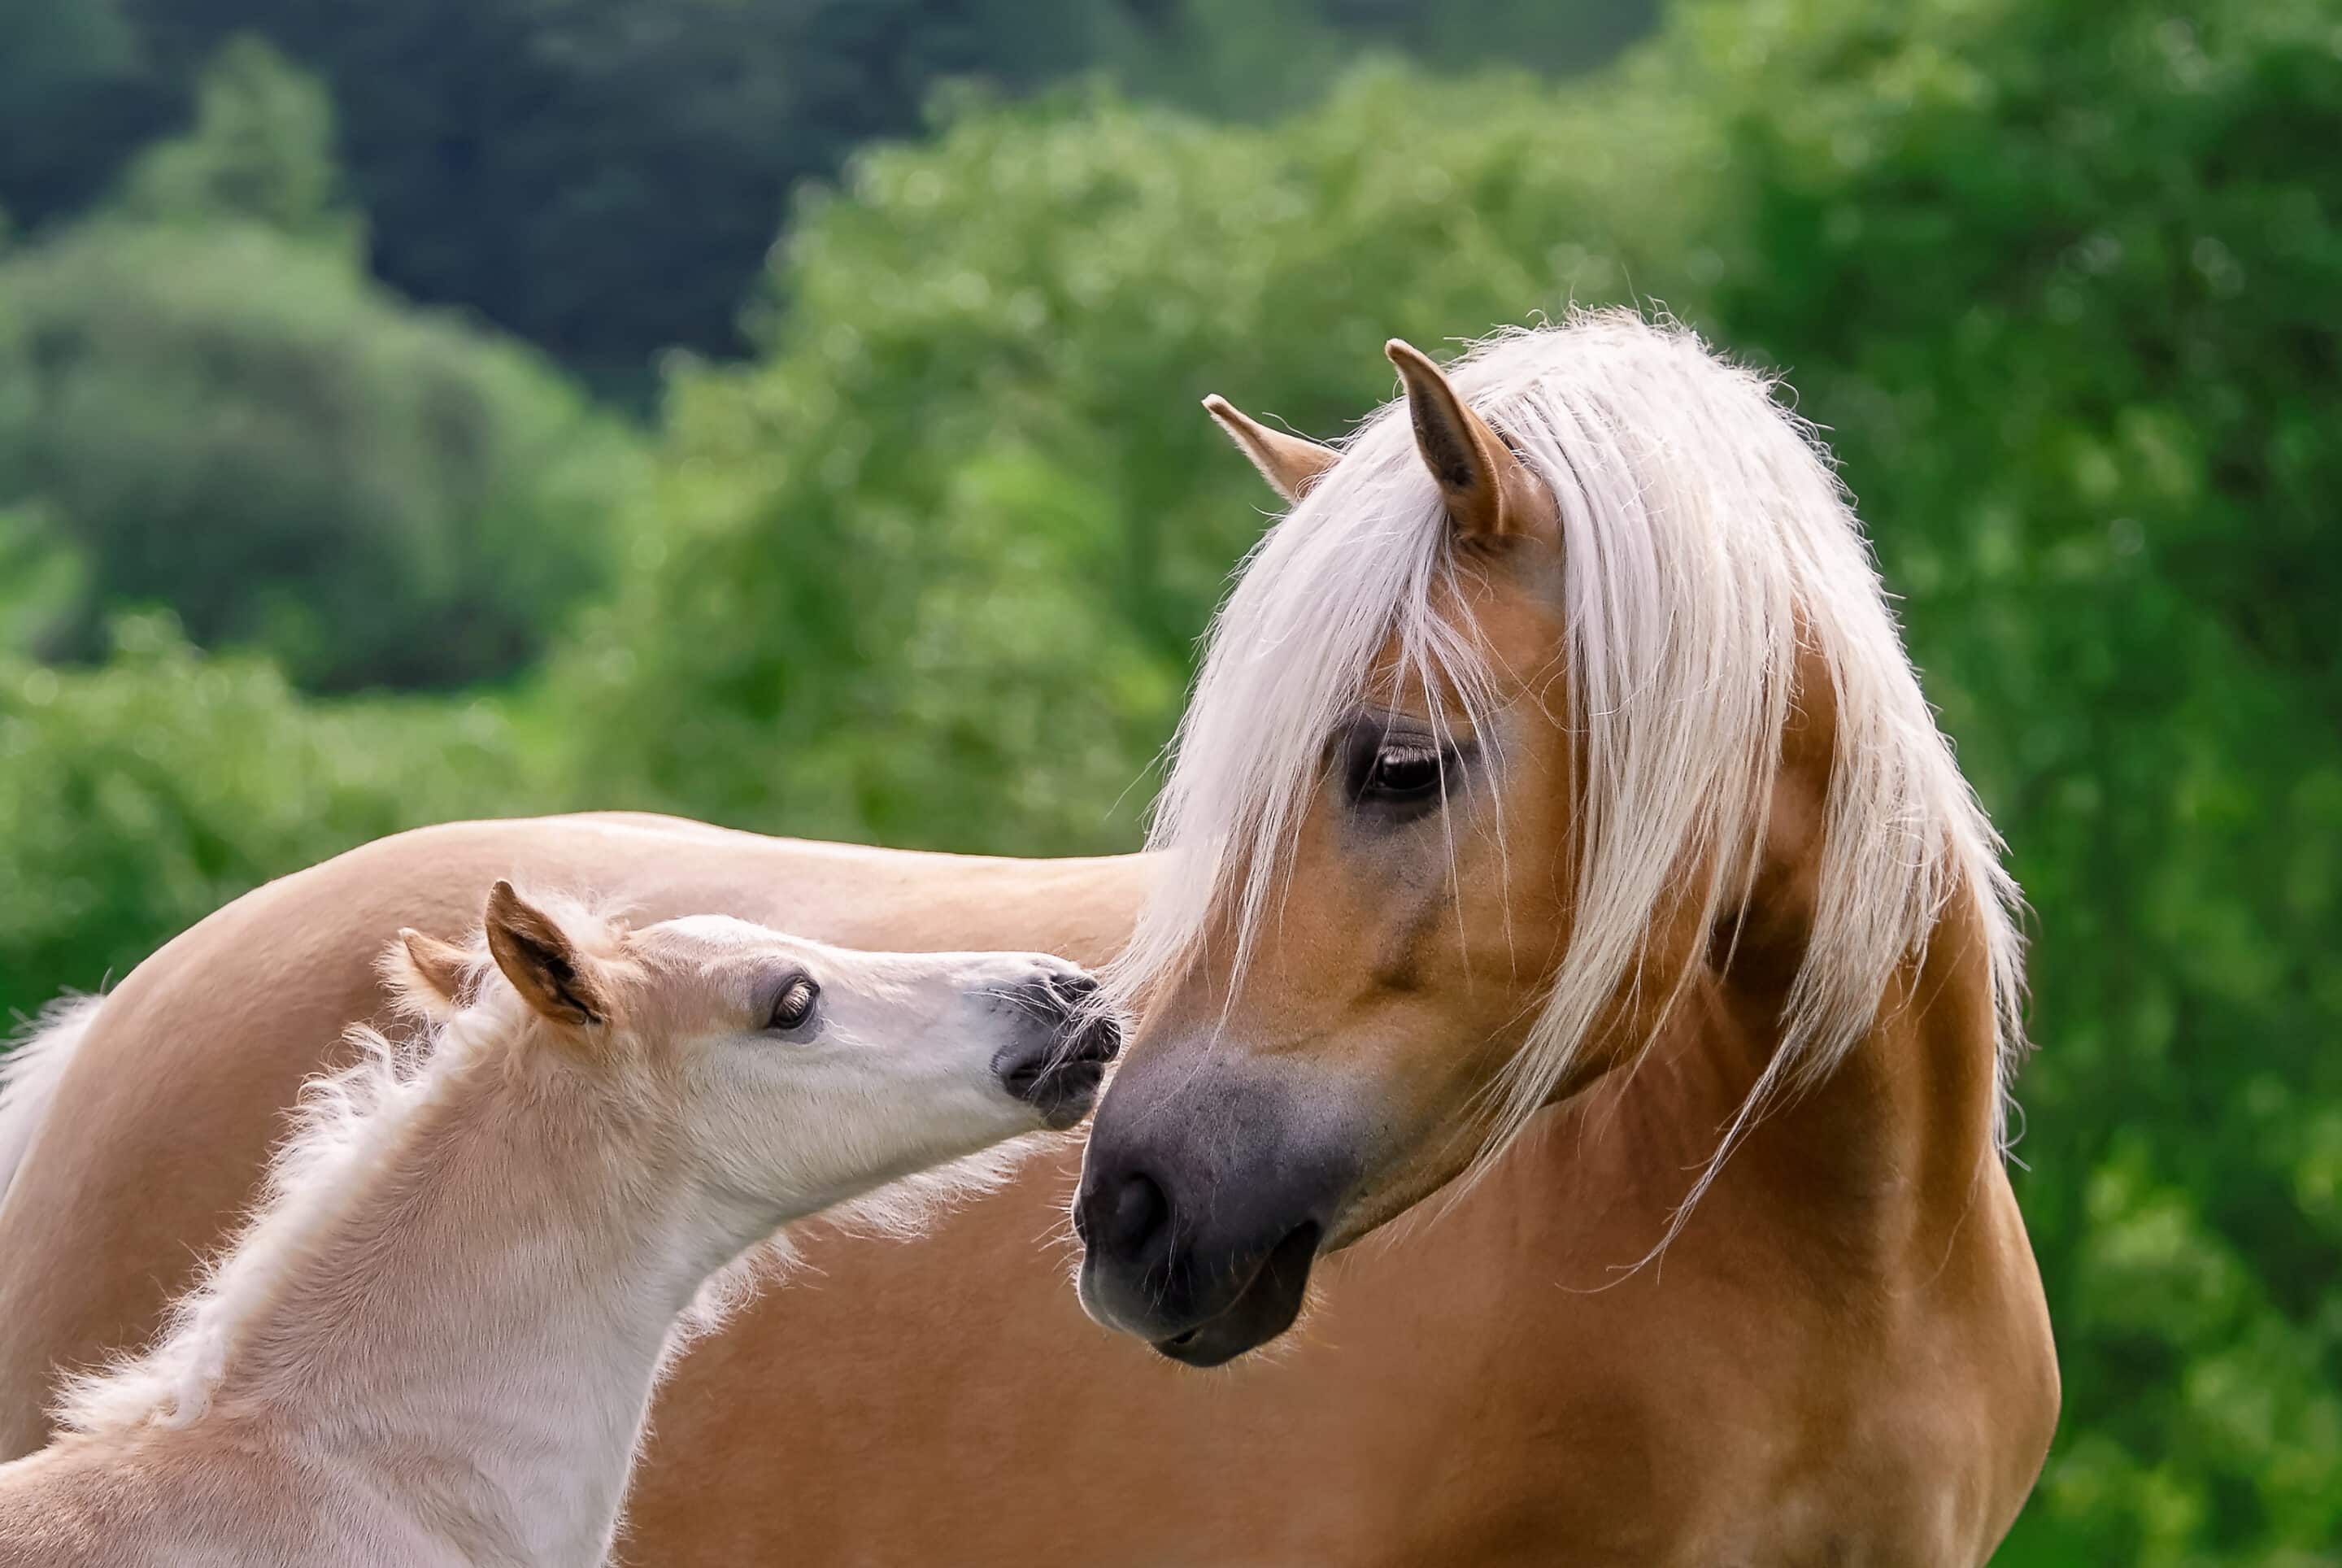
[559,72,1698,853]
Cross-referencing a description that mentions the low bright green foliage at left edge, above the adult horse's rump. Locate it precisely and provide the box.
[0,616,543,1020]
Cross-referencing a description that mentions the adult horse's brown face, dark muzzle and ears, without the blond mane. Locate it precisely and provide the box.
[1075,342,1571,1364]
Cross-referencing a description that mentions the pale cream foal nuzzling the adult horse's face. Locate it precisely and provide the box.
[0,882,1117,1568]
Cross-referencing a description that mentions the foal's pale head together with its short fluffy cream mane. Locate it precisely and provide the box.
[59,882,1120,1432]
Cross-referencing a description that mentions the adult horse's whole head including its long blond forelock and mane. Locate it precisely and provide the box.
[1075,319,1998,1364]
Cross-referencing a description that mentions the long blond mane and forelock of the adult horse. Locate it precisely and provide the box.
[1110,311,2023,1196]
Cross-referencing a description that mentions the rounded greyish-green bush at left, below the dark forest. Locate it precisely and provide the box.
[0,223,633,689]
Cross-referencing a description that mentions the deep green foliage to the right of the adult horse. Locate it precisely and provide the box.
[1688,0,2342,1563]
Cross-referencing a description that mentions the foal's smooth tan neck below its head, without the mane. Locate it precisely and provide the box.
[213,1040,724,1561]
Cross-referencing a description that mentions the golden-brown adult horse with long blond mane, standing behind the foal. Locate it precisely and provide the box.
[0,316,2059,1566]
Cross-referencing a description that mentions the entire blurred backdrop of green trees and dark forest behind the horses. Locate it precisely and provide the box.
[0,0,2342,1563]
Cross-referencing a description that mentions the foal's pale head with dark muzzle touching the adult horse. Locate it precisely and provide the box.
[394,882,1120,1238]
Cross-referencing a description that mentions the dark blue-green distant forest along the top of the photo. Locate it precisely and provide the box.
[0,0,1649,391]
